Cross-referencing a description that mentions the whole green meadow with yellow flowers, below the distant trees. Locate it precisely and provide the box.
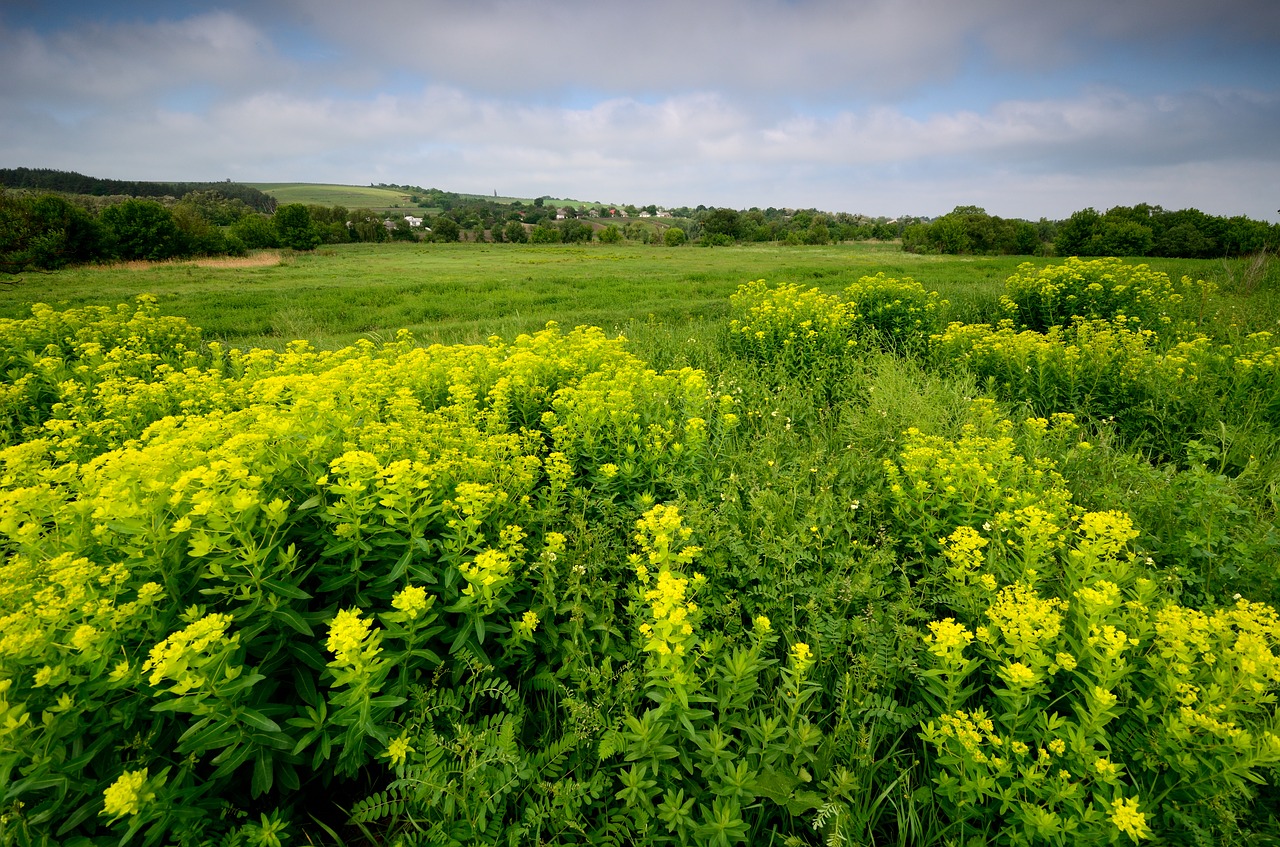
[0,244,1280,846]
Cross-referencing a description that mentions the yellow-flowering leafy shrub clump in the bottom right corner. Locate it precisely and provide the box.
[923,513,1280,844]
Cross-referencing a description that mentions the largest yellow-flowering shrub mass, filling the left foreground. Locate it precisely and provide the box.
[0,301,719,843]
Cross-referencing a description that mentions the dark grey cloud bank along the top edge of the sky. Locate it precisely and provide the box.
[288,0,1280,100]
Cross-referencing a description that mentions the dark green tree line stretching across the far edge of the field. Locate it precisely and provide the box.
[0,168,1280,274]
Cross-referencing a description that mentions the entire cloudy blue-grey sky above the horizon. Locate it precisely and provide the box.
[0,0,1280,221]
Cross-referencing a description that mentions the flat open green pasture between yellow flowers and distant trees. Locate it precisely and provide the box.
[0,241,1259,348]
